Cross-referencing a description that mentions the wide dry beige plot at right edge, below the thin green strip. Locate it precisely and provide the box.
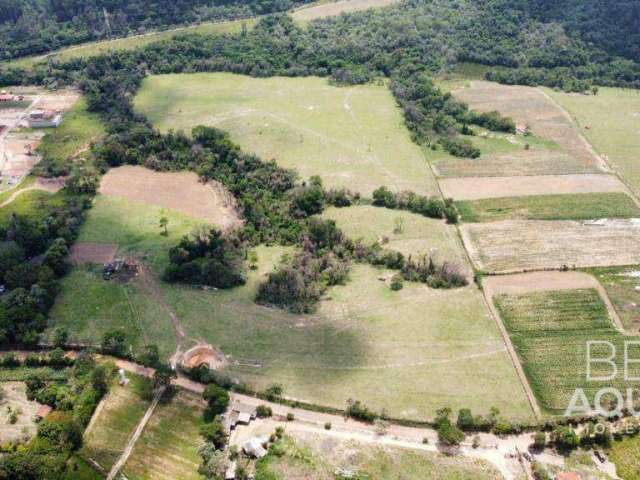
[460,219,640,273]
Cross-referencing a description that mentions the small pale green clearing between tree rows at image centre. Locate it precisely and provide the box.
[322,205,468,269]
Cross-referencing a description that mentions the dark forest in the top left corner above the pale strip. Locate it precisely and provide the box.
[0,0,309,60]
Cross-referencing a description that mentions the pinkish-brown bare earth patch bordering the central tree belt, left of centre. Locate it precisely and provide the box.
[100,166,241,230]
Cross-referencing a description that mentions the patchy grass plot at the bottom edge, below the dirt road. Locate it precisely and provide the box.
[256,435,502,480]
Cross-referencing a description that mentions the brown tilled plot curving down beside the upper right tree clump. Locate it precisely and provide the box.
[452,80,603,174]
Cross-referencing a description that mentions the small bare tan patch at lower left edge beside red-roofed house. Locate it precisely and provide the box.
[0,382,40,444]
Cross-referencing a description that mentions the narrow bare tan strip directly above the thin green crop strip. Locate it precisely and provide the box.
[440,174,627,200]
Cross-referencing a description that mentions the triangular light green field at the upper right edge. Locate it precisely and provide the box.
[546,87,640,195]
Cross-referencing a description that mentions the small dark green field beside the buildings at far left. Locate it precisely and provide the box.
[37,98,106,171]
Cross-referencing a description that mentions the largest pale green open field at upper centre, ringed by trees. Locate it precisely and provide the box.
[134,73,438,195]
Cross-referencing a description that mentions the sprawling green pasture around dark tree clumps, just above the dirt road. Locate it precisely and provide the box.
[49,189,530,419]
